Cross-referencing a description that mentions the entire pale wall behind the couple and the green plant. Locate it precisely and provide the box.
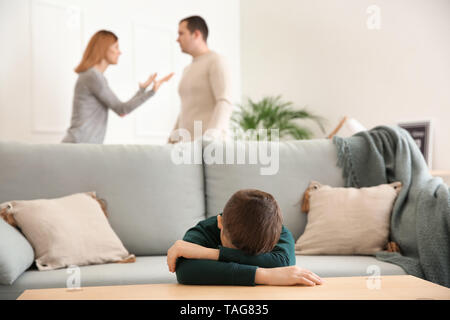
[0,0,450,170]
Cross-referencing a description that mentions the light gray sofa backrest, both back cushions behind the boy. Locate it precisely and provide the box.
[0,139,344,256]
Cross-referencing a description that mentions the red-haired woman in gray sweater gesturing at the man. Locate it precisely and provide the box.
[62,30,173,143]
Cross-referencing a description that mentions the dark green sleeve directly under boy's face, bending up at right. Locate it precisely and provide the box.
[219,226,295,268]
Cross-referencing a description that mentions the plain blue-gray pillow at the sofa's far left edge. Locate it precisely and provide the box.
[0,218,34,285]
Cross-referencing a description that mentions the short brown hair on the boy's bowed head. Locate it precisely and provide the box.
[222,189,283,255]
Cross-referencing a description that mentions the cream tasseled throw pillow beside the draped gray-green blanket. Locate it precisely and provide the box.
[295,181,401,255]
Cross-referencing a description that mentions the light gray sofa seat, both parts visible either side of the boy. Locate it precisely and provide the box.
[0,256,406,300]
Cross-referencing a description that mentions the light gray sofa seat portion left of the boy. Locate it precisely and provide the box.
[0,256,177,300]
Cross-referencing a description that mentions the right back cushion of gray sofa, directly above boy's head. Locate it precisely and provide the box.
[204,139,344,239]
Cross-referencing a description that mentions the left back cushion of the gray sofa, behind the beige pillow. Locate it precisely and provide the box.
[0,142,205,256]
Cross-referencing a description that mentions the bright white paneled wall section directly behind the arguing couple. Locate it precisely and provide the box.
[0,0,241,143]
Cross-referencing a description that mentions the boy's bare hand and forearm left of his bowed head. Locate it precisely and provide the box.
[167,240,219,272]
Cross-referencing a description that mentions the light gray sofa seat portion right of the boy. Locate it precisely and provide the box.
[296,255,407,278]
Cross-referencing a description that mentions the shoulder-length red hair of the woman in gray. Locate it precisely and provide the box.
[75,30,119,73]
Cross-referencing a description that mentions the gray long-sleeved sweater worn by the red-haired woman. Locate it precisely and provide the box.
[62,67,155,143]
